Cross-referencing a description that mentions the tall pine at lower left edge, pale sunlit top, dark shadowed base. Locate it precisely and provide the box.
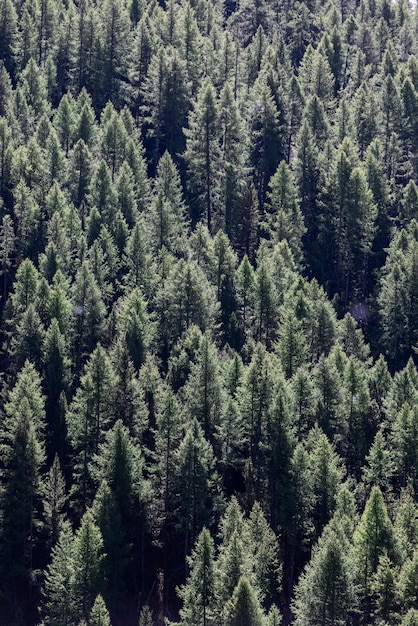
[1,363,45,602]
